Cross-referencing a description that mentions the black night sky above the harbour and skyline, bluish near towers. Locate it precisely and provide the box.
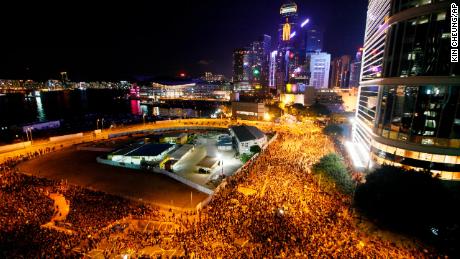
[0,0,367,81]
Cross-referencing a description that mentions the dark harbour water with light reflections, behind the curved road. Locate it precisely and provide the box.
[0,89,215,127]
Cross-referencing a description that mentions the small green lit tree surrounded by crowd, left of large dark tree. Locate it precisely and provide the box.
[313,153,355,194]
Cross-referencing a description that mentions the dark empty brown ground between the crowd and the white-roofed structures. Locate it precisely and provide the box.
[19,148,207,209]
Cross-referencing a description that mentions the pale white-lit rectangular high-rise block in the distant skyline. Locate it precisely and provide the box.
[307,52,331,89]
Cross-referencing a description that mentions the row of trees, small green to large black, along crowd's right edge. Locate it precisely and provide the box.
[313,154,460,257]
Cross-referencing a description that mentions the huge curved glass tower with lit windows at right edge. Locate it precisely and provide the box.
[354,0,460,180]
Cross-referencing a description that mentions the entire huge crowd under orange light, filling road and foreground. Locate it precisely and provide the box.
[0,123,438,258]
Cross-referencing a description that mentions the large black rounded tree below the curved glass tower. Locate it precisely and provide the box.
[354,165,459,235]
